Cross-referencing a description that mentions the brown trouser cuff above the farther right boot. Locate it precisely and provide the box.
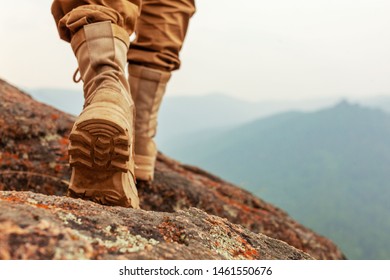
[127,0,195,72]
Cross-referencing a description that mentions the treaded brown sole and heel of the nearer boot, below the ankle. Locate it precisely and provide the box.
[68,102,139,208]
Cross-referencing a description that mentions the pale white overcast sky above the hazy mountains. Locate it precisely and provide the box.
[0,0,390,101]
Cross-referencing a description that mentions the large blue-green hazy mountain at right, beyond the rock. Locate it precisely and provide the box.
[168,99,390,259]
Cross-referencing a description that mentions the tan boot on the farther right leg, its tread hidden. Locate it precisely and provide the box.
[129,65,171,181]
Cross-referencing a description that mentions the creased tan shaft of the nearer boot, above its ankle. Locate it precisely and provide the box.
[71,22,132,107]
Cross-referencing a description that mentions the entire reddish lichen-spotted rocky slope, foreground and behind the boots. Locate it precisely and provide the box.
[0,77,345,259]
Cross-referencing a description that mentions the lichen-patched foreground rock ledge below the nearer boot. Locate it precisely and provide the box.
[0,192,311,260]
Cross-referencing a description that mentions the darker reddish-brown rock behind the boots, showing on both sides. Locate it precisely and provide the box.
[0,77,345,259]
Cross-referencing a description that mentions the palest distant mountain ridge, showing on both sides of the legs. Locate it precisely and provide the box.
[28,89,335,145]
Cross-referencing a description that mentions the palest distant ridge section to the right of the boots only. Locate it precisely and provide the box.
[156,93,335,147]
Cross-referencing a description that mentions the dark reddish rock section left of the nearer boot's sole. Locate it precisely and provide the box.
[0,79,75,195]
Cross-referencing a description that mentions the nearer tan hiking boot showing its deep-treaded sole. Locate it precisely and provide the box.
[68,22,139,208]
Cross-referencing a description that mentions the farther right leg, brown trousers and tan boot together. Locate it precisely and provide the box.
[127,0,195,180]
